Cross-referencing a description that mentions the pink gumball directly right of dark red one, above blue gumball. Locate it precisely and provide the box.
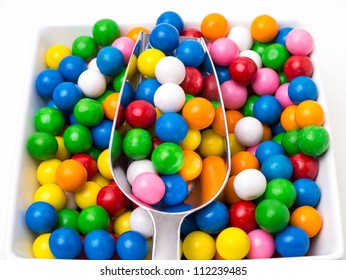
[252,67,280,95]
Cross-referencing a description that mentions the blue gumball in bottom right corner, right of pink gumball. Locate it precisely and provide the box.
[275,226,310,257]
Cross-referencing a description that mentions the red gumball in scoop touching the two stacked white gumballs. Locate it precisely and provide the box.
[180,66,203,96]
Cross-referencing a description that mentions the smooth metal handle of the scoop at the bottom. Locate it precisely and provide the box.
[149,211,186,260]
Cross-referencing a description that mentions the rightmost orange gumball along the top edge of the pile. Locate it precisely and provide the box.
[250,14,279,42]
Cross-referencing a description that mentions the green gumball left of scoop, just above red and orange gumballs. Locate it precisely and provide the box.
[63,124,92,154]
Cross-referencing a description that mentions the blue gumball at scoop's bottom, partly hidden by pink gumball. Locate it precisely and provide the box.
[161,174,188,206]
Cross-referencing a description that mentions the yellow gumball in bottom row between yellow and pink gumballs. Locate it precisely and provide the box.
[216,227,250,260]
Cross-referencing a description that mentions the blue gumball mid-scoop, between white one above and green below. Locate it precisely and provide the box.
[155,112,189,144]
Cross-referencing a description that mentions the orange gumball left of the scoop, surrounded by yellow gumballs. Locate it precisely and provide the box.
[55,159,88,192]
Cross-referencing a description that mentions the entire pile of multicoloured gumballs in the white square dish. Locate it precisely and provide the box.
[25,11,329,260]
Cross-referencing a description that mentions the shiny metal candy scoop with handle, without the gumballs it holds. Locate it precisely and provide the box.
[109,33,231,260]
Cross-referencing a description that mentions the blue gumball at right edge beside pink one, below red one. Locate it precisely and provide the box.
[287,76,318,104]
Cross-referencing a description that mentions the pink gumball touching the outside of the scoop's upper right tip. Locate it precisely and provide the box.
[210,37,239,66]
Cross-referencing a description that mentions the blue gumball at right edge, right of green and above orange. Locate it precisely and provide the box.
[293,178,321,207]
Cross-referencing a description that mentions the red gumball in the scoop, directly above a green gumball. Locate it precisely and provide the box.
[125,100,156,129]
